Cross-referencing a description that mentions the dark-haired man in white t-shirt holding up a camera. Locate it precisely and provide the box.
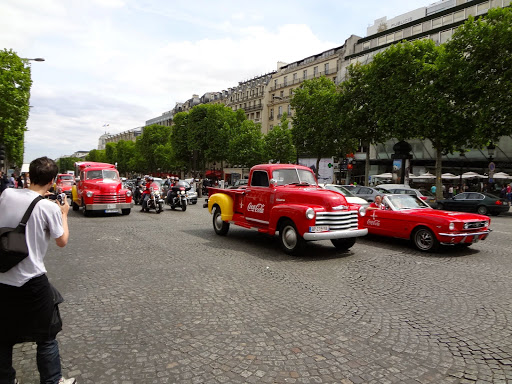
[0,157,76,384]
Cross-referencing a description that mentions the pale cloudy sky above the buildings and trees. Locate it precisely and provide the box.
[0,0,433,162]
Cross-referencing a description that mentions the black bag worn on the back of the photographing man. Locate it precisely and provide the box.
[0,196,43,273]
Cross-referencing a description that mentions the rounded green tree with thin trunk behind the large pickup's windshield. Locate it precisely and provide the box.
[291,76,340,177]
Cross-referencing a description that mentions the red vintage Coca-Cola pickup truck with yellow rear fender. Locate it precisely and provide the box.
[204,164,368,254]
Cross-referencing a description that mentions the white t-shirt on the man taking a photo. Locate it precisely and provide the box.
[0,189,64,287]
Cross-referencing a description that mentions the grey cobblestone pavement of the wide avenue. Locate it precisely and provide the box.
[14,203,512,384]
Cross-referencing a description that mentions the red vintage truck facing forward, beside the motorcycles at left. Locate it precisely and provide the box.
[72,162,133,216]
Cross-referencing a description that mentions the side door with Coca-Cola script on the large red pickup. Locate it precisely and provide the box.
[240,170,274,227]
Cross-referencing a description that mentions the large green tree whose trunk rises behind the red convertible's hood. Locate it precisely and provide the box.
[370,40,473,198]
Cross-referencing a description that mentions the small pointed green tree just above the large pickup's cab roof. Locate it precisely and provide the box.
[263,112,297,164]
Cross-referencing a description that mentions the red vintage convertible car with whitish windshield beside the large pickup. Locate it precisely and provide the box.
[359,195,491,252]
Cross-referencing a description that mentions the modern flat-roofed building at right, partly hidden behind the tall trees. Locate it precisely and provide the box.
[337,0,512,184]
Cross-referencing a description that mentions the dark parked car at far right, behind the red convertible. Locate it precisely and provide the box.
[437,192,510,216]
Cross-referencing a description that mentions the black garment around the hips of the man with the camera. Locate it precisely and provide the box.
[0,275,64,343]
